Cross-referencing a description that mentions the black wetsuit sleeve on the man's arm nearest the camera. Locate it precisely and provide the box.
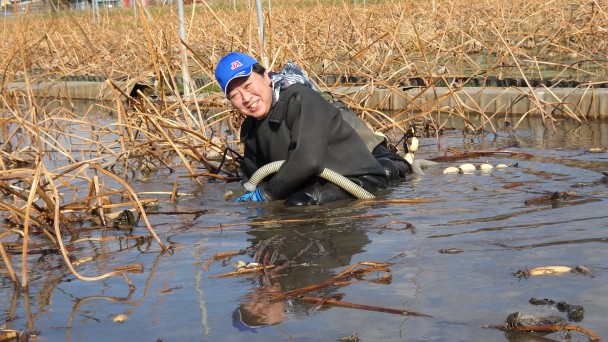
[261,90,340,199]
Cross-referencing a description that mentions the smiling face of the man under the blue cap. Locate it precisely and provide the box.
[228,72,272,119]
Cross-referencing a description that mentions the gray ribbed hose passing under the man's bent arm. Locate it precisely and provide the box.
[244,160,376,199]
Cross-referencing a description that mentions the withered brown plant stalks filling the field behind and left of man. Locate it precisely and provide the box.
[0,0,608,286]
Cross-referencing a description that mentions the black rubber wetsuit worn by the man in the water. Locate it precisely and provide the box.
[241,84,389,205]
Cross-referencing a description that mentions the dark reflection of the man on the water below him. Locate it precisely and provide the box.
[228,203,370,330]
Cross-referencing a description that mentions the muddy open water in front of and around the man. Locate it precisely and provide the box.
[0,113,608,341]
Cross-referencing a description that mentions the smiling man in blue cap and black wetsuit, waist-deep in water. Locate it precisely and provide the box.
[215,52,409,206]
